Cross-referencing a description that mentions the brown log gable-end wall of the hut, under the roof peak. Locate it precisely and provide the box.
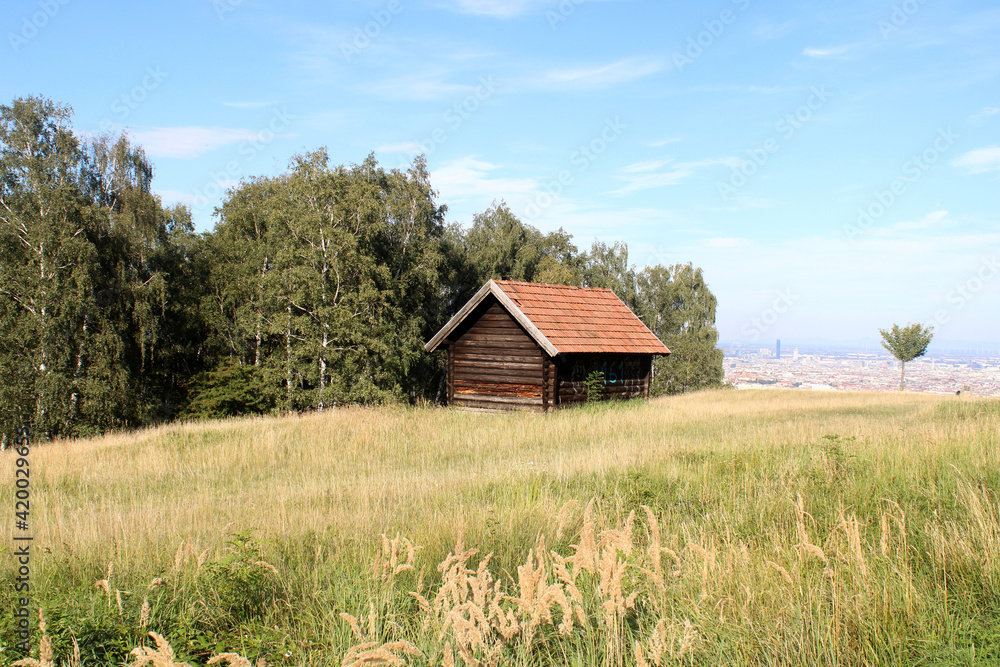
[448,302,556,410]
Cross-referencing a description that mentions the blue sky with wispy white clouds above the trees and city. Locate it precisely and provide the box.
[0,0,1000,349]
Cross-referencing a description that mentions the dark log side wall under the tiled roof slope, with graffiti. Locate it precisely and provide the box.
[556,354,652,405]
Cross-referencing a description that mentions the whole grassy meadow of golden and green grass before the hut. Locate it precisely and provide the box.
[0,391,1000,667]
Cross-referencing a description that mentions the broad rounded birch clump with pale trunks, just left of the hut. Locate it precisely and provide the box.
[192,149,443,418]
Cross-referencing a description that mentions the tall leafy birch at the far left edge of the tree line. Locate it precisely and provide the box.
[0,98,88,433]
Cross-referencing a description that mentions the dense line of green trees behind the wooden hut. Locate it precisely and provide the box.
[0,97,722,436]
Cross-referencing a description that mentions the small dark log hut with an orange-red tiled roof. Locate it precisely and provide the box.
[424,280,670,411]
